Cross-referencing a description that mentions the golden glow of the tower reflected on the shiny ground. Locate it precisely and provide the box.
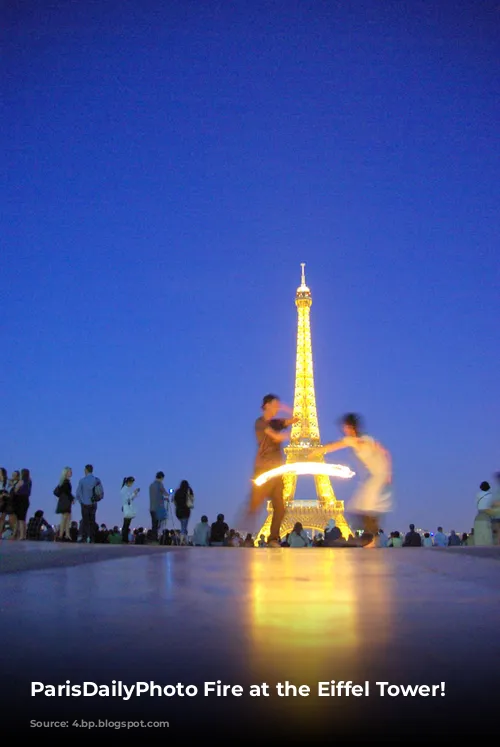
[249,548,391,732]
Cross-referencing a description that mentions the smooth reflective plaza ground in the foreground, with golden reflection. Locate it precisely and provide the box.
[0,541,500,743]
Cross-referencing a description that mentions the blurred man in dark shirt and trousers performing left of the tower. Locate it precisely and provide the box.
[248,394,298,547]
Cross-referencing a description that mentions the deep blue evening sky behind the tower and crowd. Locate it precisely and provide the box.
[0,0,500,531]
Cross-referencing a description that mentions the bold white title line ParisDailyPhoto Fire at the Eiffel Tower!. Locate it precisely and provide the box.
[31,680,446,701]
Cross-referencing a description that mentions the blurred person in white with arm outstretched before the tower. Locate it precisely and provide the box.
[313,413,392,542]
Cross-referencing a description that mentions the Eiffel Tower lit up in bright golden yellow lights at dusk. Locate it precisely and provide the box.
[257,263,352,539]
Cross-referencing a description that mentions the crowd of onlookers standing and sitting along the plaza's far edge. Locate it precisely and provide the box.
[0,464,500,548]
